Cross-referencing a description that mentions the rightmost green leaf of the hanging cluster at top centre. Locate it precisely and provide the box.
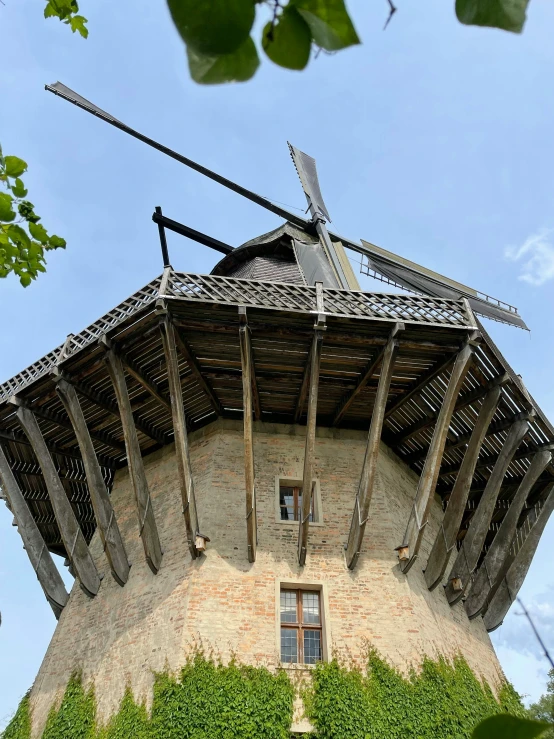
[291,0,360,51]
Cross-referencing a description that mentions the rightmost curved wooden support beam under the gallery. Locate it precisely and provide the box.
[483,485,554,631]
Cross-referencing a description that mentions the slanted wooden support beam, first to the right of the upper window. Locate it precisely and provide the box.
[346,324,404,570]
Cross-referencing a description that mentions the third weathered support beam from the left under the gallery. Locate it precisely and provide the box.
[56,379,129,585]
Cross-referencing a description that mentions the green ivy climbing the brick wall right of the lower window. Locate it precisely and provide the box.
[305,650,524,739]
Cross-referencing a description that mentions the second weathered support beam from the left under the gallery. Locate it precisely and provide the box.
[13,405,100,597]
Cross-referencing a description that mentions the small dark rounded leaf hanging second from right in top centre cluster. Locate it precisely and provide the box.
[262,5,312,69]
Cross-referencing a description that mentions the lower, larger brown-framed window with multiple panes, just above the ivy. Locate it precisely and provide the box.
[281,589,322,665]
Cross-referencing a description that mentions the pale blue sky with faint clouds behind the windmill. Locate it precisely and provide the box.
[0,0,554,727]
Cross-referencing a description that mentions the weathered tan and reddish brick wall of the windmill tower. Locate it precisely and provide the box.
[31,421,502,733]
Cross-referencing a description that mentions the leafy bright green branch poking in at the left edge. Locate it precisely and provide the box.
[0,147,65,287]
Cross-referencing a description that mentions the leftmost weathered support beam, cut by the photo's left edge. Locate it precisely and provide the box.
[0,445,69,618]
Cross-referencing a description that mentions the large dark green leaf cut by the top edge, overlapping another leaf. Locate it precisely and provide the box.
[167,0,255,56]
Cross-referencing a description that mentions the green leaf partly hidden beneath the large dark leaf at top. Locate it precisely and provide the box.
[187,37,260,85]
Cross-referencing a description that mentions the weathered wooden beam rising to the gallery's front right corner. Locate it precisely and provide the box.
[400,341,474,572]
